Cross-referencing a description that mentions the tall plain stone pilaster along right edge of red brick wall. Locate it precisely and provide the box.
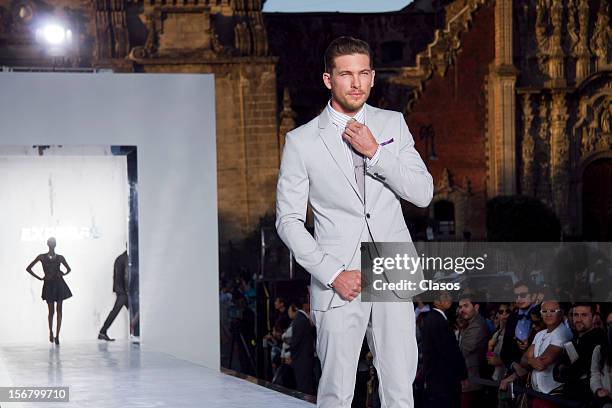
[487,0,517,197]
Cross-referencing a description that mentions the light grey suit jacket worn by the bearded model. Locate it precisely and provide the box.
[276,105,433,310]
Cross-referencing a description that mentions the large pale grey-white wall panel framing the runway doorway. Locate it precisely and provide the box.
[0,73,219,368]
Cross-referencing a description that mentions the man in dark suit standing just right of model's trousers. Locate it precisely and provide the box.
[421,292,468,408]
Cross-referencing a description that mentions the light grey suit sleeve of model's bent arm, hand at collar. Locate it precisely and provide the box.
[371,113,433,207]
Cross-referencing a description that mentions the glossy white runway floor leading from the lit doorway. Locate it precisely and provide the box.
[0,341,314,408]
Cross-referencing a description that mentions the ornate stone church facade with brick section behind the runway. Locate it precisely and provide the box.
[0,0,612,244]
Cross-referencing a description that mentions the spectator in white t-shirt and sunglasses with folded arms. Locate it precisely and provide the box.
[521,300,572,408]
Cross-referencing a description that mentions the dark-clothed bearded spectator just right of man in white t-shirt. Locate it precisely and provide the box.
[555,303,606,401]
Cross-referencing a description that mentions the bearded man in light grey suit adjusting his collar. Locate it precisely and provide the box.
[276,37,433,408]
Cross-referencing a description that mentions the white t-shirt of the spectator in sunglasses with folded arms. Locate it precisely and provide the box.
[531,322,573,394]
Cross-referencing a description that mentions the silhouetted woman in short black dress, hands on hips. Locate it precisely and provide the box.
[26,237,72,345]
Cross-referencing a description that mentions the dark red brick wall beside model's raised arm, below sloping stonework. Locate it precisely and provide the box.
[408,6,495,238]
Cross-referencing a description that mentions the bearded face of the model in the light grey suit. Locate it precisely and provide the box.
[323,54,374,115]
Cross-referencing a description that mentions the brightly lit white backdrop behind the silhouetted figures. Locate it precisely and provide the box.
[0,154,128,343]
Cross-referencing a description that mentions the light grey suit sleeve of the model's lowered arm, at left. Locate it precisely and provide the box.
[276,132,345,290]
